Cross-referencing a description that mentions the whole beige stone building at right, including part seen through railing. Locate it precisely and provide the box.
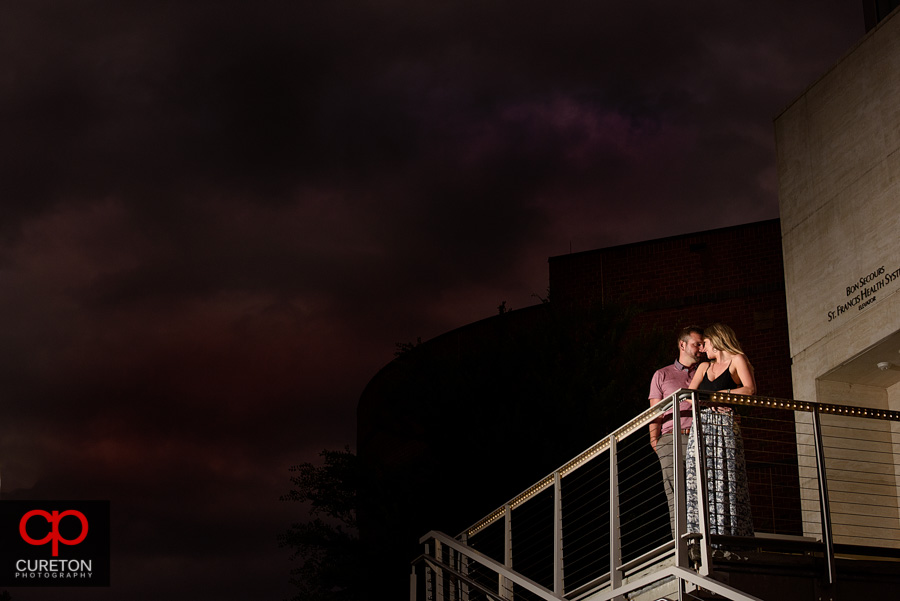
[775,5,900,547]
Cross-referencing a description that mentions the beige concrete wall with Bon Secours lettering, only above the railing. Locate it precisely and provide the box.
[775,8,900,399]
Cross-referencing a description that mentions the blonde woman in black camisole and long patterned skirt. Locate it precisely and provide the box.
[685,323,756,536]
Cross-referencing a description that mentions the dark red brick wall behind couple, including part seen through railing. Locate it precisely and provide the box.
[550,220,796,534]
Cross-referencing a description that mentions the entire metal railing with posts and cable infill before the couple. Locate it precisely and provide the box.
[411,390,900,601]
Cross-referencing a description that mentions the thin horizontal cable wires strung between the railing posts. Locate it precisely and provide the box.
[418,395,900,601]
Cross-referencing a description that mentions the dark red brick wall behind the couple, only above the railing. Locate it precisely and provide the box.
[549,219,792,398]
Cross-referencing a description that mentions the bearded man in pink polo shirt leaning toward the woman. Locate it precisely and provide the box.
[649,326,703,533]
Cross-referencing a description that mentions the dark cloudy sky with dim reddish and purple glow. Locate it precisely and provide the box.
[0,0,864,601]
